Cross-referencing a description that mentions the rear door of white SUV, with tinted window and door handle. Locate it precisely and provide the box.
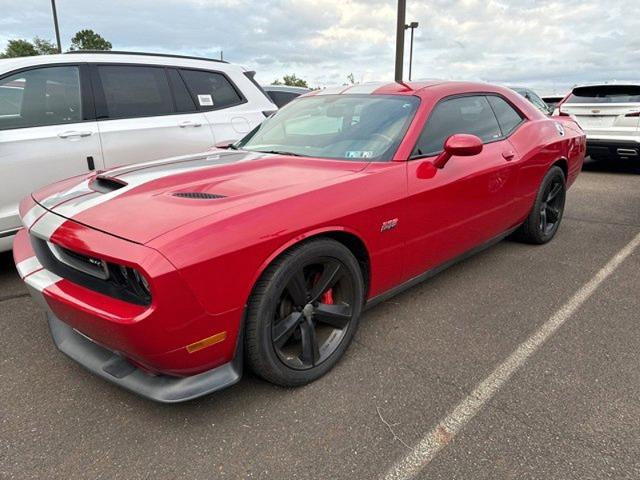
[92,64,214,167]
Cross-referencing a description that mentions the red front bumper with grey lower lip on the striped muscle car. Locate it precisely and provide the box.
[14,214,242,402]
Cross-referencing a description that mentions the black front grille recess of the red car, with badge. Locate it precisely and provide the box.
[31,235,151,306]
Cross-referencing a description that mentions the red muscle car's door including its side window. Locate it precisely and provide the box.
[405,95,517,278]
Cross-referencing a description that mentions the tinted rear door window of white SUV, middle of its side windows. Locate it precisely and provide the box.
[98,66,174,118]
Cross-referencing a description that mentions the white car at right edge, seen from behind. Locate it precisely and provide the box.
[556,84,640,160]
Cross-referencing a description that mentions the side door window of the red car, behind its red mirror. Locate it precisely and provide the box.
[414,96,502,155]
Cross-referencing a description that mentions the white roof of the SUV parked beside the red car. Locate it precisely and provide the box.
[0,51,245,73]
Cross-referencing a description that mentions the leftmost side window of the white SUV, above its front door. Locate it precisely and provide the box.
[0,66,82,130]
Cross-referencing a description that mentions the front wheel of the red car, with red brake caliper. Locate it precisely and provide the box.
[245,239,364,387]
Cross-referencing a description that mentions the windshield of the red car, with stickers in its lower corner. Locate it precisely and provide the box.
[234,95,419,161]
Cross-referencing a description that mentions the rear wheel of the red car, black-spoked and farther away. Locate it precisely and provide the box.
[515,166,566,245]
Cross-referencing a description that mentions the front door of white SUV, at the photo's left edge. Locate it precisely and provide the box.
[0,64,102,239]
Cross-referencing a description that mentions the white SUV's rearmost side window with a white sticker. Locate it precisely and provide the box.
[181,70,242,109]
